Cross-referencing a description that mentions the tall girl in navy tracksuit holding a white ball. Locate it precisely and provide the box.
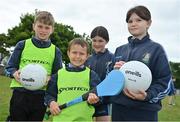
[112,6,171,121]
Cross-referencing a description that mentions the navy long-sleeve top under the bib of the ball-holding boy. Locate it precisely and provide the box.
[6,37,62,91]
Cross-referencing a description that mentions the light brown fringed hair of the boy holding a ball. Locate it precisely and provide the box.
[34,11,55,26]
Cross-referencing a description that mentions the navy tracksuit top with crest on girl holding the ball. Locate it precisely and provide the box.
[112,35,171,111]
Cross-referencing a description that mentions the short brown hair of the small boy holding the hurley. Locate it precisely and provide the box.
[68,38,90,54]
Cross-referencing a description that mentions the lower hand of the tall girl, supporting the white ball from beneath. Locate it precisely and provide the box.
[123,89,147,101]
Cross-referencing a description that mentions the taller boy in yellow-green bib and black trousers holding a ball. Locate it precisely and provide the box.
[6,11,62,121]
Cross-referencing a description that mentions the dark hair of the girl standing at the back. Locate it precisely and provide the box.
[91,26,109,42]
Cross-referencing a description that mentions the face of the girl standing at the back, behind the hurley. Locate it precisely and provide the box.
[92,36,107,53]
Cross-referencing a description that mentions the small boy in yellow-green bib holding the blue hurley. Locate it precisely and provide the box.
[45,38,100,122]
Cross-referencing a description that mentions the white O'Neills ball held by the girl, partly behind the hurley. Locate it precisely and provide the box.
[120,61,152,93]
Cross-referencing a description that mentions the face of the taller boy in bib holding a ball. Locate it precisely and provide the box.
[33,21,53,41]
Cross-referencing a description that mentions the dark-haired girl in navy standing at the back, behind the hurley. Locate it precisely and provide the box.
[86,26,114,121]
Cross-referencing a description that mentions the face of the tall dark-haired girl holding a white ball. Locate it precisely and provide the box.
[128,13,151,39]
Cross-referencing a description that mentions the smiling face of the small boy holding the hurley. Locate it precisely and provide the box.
[67,44,88,67]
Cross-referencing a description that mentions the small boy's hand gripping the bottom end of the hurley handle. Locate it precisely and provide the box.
[50,101,61,115]
